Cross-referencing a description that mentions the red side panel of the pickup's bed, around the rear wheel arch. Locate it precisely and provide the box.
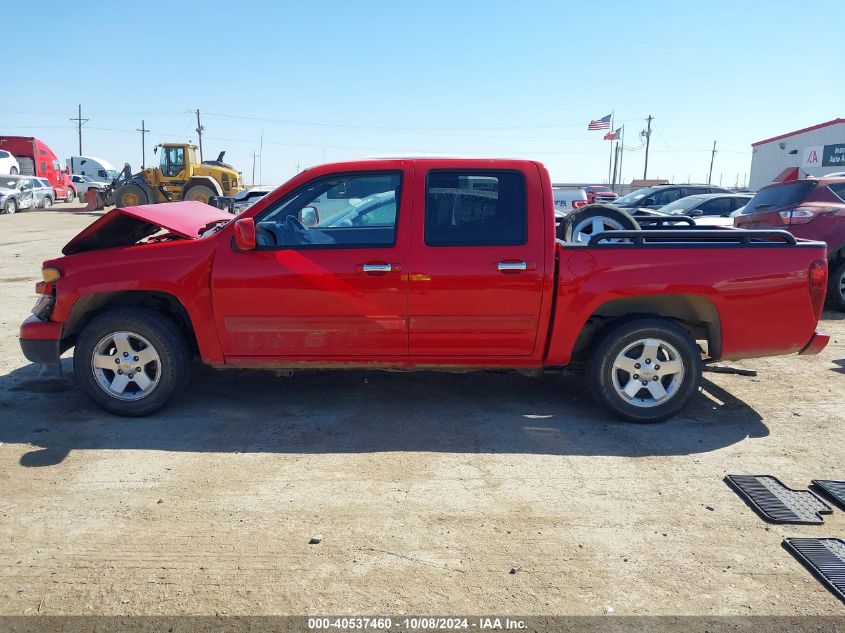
[547,243,825,365]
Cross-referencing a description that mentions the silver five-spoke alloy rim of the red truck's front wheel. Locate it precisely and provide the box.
[91,332,161,400]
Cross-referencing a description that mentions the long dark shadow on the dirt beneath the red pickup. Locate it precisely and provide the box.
[0,360,768,467]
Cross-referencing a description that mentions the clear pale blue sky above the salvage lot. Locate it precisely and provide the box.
[0,0,845,185]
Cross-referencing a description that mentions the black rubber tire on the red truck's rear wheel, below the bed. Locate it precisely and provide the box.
[586,317,702,423]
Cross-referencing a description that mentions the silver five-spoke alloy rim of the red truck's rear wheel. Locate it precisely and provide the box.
[611,338,684,408]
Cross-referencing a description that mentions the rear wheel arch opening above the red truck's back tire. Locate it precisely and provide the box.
[572,294,722,359]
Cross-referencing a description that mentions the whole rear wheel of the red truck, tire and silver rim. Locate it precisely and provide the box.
[587,318,701,423]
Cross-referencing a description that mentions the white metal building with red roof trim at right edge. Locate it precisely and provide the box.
[748,119,845,191]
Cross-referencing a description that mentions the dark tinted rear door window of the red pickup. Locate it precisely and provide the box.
[425,170,528,246]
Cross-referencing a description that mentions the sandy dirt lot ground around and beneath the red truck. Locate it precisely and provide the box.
[0,205,845,615]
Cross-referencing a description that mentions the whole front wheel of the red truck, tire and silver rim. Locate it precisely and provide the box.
[73,307,190,416]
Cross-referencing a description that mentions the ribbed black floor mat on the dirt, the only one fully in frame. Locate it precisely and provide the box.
[725,475,833,525]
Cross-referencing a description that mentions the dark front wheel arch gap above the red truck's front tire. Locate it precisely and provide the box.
[61,290,199,353]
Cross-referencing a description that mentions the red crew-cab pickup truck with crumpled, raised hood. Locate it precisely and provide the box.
[20,158,828,422]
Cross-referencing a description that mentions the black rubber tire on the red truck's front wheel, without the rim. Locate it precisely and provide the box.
[73,307,191,417]
